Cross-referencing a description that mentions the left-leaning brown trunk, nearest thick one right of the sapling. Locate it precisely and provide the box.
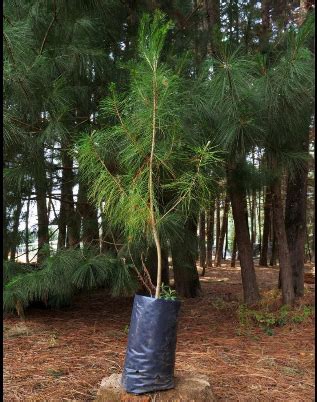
[228,170,260,304]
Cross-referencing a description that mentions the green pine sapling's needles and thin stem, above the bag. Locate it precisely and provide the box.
[75,11,220,298]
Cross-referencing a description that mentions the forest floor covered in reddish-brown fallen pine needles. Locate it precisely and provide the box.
[4,264,315,402]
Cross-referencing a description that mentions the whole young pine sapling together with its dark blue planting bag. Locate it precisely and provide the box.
[76,11,219,394]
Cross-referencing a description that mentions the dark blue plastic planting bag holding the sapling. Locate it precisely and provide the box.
[122,295,180,394]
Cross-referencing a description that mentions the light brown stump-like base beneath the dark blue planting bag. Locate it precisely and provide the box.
[95,372,216,402]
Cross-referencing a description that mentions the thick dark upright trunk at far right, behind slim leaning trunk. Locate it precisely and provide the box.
[285,138,309,296]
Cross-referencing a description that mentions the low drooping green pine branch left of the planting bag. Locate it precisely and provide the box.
[3,249,138,316]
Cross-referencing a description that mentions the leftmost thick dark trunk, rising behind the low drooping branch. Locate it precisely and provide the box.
[34,145,49,264]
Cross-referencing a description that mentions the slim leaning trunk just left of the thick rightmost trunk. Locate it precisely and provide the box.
[272,176,295,304]
